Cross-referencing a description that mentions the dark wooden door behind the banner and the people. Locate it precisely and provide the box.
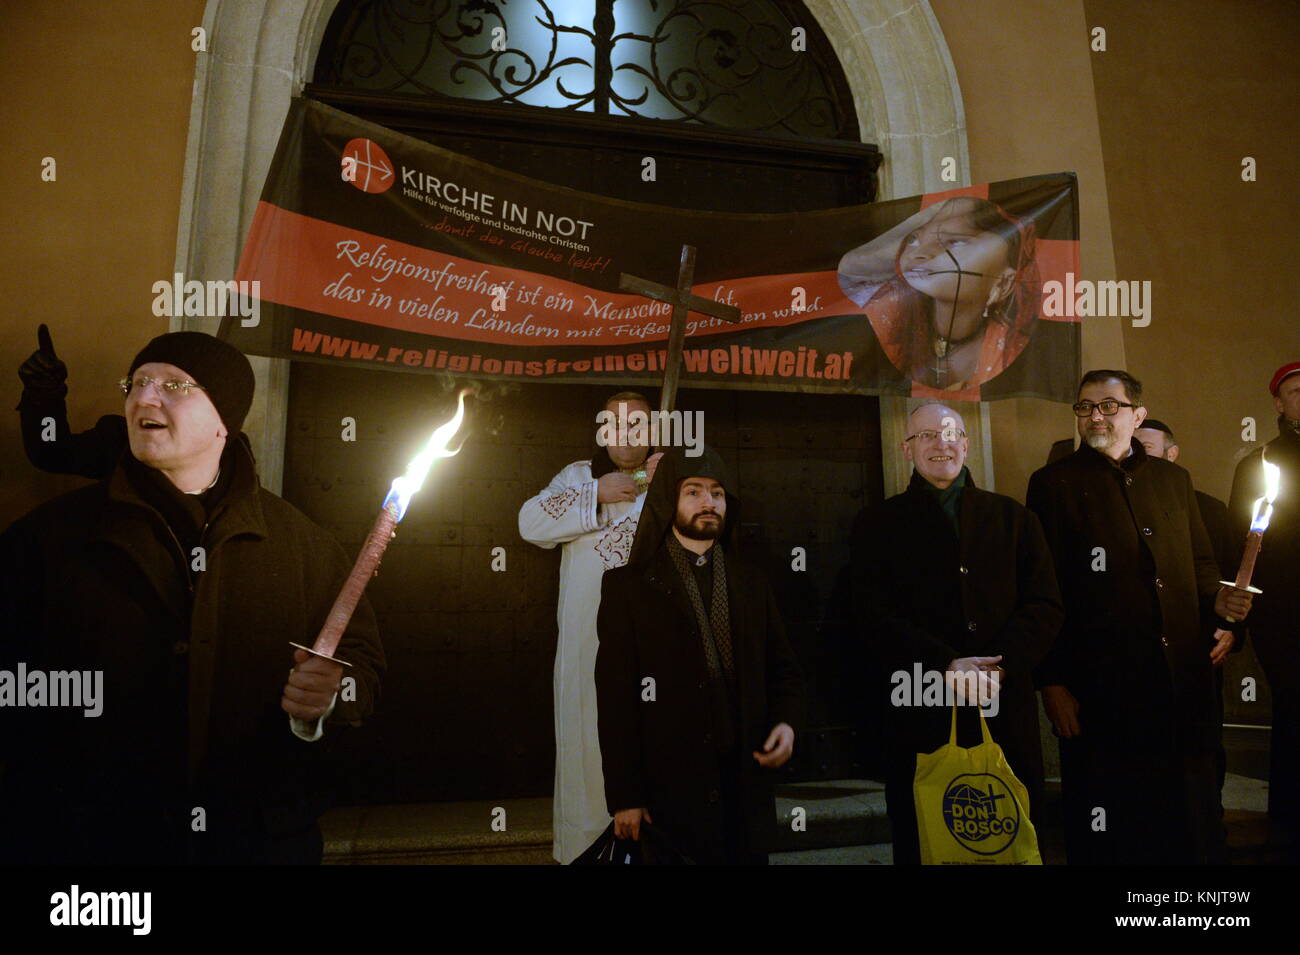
[285,90,881,803]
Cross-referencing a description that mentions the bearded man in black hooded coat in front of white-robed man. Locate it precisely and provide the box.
[595,448,803,864]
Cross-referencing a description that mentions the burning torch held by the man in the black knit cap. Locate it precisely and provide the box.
[290,391,465,667]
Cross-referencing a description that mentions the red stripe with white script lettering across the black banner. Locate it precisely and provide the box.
[237,201,866,346]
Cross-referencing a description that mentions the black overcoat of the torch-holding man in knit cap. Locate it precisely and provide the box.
[0,440,384,863]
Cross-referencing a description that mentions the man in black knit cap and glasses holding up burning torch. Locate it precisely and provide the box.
[0,331,384,864]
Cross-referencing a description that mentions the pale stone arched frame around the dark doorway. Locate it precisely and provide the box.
[172,0,977,494]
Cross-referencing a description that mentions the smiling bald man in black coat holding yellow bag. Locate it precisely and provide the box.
[852,403,1063,865]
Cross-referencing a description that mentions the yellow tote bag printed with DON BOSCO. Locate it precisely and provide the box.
[911,706,1043,865]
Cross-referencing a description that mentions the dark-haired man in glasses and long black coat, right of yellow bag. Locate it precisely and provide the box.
[1027,369,1251,864]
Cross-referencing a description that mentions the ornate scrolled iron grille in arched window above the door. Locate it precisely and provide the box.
[315,0,858,140]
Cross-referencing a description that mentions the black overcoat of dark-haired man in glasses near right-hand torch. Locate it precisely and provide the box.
[1026,440,1234,752]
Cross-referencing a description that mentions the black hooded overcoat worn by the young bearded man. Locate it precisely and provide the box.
[595,450,803,863]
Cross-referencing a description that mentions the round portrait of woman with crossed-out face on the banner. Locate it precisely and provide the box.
[839,196,1040,391]
